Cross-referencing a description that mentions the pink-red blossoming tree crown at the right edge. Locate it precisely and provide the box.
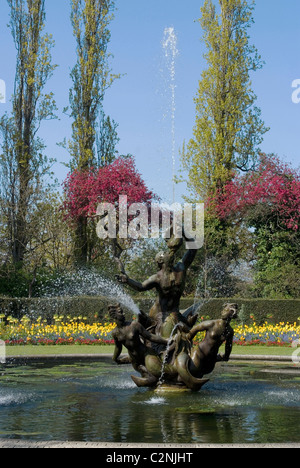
[216,154,300,232]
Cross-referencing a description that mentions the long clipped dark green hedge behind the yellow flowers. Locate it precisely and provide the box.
[0,296,300,324]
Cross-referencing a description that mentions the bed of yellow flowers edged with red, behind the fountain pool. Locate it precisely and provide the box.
[0,316,300,347]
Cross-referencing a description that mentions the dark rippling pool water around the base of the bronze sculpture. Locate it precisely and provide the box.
[0,362,300,444]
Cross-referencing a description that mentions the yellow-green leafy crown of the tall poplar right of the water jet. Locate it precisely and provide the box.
[182,0,267,200]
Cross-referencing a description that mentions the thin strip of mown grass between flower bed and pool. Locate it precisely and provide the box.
[6,345,293,357]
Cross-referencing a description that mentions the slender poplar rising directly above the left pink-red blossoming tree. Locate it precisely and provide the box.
[69,0,117,265]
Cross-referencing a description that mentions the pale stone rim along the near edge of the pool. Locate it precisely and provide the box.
[0,439,300,452]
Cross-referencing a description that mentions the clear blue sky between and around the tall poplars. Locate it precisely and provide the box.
[0,0,300,201]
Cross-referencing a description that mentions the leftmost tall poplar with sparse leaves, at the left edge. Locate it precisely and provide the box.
[0,0,56,266]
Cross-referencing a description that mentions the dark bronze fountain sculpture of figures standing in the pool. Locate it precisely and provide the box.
[109,228,238,391]
